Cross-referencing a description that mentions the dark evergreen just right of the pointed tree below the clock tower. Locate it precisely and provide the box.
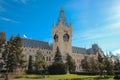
[66,54,76,73]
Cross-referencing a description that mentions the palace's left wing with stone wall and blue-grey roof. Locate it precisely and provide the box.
[22,38,54,65]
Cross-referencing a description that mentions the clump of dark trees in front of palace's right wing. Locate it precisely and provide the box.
[81,53,120,77]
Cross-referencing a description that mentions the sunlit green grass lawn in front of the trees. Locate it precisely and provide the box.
[14,74,114,80]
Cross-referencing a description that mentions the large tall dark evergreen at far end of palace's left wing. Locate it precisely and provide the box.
[3,35,24,72]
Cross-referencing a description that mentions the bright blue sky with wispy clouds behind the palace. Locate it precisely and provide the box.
[0,0,120,52]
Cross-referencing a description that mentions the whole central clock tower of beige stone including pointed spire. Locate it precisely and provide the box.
[52,8,72,58]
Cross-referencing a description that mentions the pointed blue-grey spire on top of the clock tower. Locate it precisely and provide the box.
[57,7,68,26]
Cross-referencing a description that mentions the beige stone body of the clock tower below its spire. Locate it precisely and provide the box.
[52,22,72,62]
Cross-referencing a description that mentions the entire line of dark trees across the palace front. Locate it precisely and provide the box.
[0,35,120,76]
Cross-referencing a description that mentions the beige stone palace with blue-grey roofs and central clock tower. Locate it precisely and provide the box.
[22,9,104,72]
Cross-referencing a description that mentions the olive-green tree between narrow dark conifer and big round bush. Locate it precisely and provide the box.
[35,50,47,74]
